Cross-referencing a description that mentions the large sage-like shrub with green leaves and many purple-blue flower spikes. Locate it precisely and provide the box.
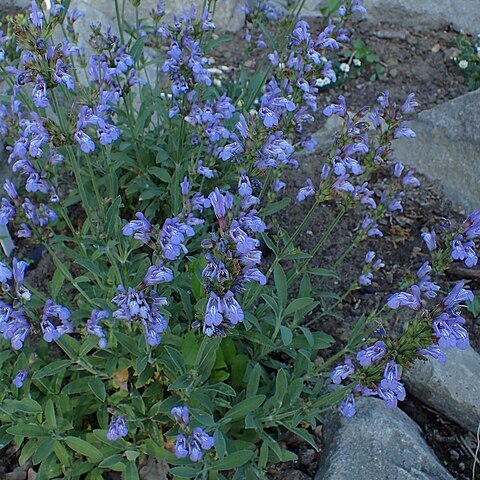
[0,0,480,480]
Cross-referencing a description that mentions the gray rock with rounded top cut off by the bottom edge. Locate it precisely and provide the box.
[315,398,453,480]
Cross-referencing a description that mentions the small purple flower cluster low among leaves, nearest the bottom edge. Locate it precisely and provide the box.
[170,406,215,462]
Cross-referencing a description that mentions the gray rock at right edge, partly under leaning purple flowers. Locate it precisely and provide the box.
[403,348,480,432]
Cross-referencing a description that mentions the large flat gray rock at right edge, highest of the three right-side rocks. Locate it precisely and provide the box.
[394,88,480,210]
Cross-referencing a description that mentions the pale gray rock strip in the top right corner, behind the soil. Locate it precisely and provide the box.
[363,0,480,34]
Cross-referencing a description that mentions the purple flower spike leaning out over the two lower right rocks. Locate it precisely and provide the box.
[331,225,475,417]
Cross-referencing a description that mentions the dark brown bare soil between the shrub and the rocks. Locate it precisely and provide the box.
[0,8,480,480]
